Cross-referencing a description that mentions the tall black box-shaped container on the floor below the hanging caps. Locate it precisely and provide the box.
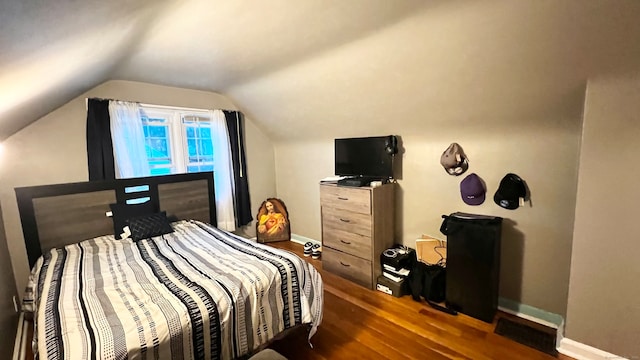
[440,212,502,323]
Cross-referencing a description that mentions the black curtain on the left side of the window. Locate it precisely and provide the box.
[87,99,116,181]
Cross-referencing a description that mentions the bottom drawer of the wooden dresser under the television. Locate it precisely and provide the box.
[322,248,373,289]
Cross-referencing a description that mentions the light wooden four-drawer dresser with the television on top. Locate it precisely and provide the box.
[320,183,396,289]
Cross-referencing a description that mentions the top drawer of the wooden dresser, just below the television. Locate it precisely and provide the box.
[320,185,371,214]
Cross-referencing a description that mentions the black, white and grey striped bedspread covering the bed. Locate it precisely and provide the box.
[27,221,323,359]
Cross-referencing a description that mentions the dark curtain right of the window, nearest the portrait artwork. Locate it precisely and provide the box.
[224,110,253,227]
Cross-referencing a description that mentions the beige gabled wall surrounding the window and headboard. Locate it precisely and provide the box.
[0,81,275,295]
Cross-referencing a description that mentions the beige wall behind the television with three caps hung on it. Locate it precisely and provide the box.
[276,115,581,316]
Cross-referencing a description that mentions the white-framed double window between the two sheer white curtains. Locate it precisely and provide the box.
[140,106,214,175]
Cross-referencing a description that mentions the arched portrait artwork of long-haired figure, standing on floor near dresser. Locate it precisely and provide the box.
[256,198,291,243]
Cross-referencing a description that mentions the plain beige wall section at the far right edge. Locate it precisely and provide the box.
[565,73,640,359]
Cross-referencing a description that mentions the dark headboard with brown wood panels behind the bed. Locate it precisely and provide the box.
[15,172,217,267]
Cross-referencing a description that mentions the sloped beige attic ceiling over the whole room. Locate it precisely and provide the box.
[0,0,640,141]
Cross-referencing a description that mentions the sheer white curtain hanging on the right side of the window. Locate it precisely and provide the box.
[209,110,236,231]
